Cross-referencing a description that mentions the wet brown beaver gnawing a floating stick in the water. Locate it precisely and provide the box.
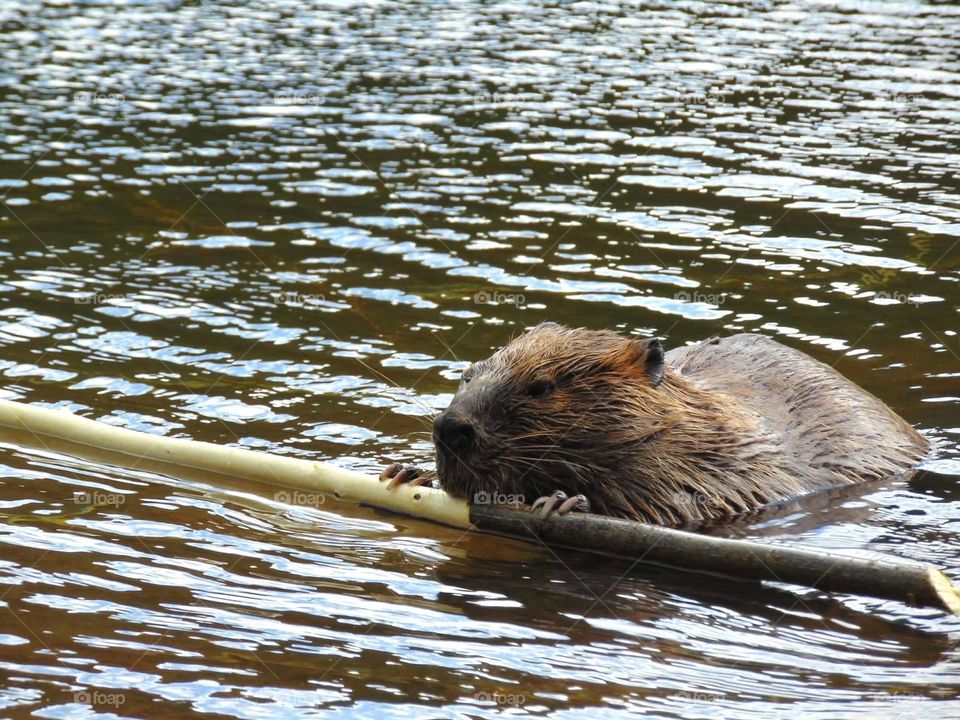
[382,323,929,525]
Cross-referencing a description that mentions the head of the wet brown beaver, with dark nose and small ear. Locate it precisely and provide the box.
[433,323,665,514]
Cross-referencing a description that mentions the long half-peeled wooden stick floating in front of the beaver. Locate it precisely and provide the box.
[0,400,960,614]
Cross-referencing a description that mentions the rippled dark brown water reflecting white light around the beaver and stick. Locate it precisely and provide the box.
[0,0,960,718]
